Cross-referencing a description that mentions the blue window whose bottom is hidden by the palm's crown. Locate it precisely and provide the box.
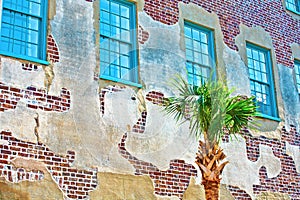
[184,23,214,86]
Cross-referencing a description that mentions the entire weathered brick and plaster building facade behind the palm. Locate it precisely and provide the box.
[0,0,300,200]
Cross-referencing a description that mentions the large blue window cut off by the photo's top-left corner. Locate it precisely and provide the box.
[0,0,48,64]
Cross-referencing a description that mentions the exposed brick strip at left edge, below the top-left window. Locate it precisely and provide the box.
[0,82,71,112]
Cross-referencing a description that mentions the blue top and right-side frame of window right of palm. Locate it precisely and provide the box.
[246,42,279,117]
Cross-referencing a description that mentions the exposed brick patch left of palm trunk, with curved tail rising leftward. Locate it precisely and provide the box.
[119,133,197,199]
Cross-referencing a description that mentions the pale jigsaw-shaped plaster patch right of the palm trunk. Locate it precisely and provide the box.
[221,136,281,198]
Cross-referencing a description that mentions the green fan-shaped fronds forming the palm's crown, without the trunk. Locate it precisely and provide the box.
[164,75,258,145]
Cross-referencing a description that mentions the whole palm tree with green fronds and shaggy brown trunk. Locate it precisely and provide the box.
[165,76,258,200]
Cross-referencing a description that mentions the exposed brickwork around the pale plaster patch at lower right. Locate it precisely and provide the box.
[223,126,300,200]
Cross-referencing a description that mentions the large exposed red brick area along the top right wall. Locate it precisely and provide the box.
[144,0,300,67]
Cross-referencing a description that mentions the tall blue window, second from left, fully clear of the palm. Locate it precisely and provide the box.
[100,0,139,86]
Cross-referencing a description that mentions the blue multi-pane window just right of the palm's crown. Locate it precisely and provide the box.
[247,44,278,119]
